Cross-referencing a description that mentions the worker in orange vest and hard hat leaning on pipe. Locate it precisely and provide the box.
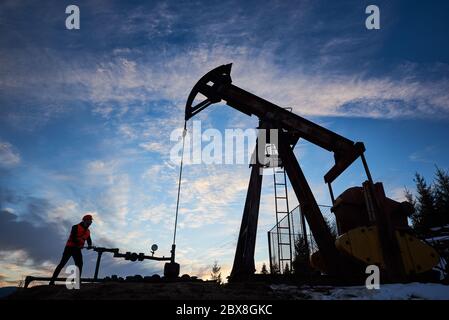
[50,214,93,285]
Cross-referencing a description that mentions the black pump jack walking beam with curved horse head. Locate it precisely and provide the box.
[185,64,365,183]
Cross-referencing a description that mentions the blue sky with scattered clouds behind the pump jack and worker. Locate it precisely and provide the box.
[0,0,449,284]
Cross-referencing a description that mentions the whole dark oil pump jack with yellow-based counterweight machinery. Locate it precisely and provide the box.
[185,64,439,282]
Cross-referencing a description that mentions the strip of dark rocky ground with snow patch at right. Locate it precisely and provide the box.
[6,281,449,301]
